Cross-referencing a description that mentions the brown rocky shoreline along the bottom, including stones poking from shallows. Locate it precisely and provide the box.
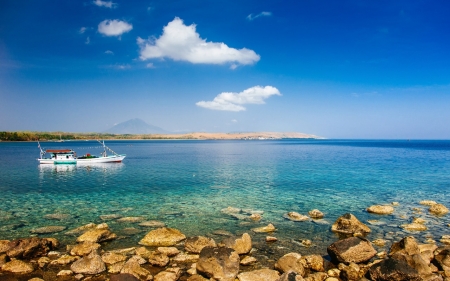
[0,201,450,281]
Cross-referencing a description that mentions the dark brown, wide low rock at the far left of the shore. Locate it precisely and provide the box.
[6,237,58,259]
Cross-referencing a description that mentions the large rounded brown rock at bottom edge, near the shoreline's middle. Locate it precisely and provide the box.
[196,247,240,281]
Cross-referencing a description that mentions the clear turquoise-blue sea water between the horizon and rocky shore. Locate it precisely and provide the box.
[0,140,450,255]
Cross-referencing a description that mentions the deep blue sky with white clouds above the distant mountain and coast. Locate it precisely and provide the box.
[0,0,450,139]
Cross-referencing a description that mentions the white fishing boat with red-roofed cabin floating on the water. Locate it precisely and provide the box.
[38,140,126,165]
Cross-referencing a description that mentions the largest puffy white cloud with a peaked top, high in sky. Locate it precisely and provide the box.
[137,17,260,65]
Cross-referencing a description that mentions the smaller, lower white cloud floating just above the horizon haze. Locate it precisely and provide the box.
[196,86,281,111]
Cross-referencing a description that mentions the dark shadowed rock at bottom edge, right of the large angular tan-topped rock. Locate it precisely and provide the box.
[369,259,422,281]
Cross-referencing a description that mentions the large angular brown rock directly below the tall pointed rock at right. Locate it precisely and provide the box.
[327,237,377,263]
